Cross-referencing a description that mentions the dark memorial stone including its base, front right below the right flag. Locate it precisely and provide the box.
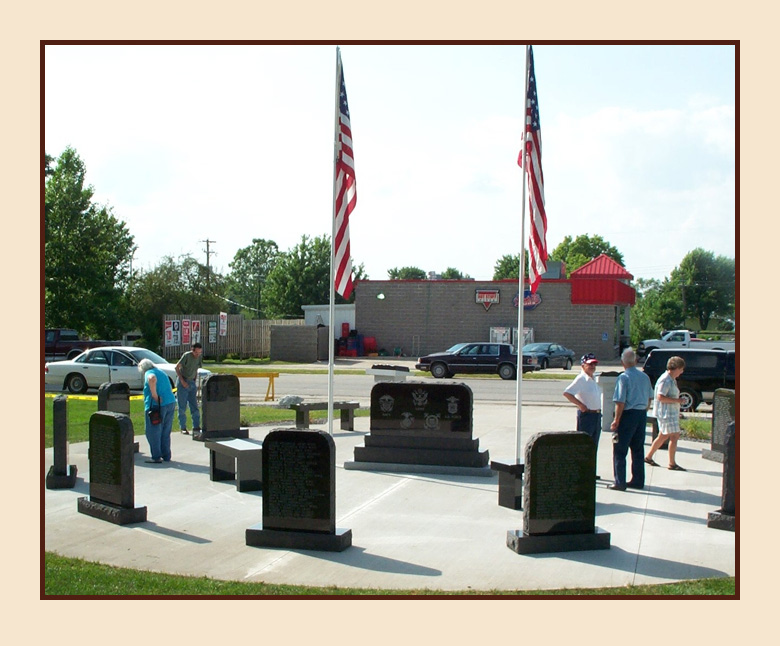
[507,431,610,554]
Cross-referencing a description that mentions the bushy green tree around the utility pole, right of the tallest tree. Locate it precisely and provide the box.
[127,255,226,348]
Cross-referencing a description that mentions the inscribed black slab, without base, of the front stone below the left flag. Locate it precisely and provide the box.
[263,430,336,534]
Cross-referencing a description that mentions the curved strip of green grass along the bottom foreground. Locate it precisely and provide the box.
[44,552,736,597]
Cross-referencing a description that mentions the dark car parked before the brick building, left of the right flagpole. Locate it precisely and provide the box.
[414,343,537,379]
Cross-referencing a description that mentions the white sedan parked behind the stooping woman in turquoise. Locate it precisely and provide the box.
[43,346,211,393]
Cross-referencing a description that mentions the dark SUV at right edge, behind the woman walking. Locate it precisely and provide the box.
[644,348,736,411]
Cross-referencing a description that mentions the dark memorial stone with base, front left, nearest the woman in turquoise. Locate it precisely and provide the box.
[78,411,146,525]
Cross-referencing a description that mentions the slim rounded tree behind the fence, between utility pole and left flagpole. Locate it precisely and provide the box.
[227,238,279,318]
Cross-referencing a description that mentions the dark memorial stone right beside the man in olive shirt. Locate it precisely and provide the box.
[200,374,249,441]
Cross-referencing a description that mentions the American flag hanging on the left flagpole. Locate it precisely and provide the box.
[333,51,357,299]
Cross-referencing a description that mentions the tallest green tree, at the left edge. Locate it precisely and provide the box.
[44,148,136,338]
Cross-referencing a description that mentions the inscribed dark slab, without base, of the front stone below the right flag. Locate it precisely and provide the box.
[523,432,596,535]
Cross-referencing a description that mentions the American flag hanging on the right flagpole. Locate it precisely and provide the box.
[517,45,547,294]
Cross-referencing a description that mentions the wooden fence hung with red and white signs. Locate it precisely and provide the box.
[162,314,304,361]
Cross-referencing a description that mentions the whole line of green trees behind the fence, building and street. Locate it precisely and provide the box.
[44,147,735,347]
